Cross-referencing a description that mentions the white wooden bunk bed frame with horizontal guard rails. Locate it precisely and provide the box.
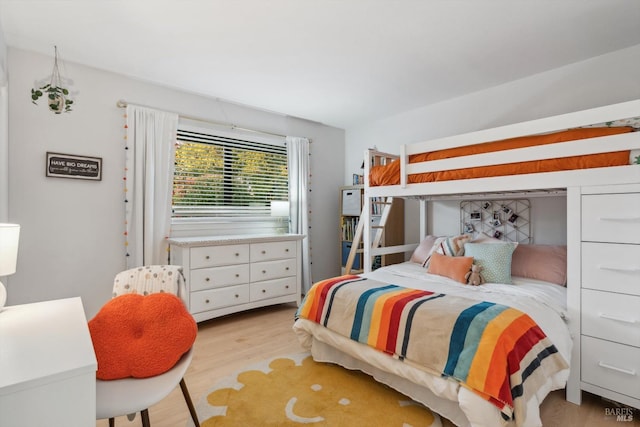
[363,100,640,410]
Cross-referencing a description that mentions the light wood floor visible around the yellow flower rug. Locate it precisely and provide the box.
[96,304,640,427]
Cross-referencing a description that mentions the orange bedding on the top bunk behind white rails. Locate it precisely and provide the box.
[369,127,634,186]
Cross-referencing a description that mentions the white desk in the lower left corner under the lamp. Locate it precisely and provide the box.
[0,298,97,427]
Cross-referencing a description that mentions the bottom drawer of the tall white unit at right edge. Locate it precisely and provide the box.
[582,336,640,399]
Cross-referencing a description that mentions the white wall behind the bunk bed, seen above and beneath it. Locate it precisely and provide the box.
[344,45,640,244]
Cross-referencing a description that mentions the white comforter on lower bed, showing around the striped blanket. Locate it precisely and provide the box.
[294,263,572,427]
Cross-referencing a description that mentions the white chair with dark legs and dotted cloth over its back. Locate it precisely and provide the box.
[96,265,200,427]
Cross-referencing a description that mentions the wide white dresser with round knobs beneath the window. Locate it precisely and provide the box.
[169,234,304,322]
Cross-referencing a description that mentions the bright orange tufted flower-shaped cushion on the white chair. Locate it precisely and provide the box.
[89,293,198,380]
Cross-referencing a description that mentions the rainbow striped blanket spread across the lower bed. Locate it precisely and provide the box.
[296,275,568,420]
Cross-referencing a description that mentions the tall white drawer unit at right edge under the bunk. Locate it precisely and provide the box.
[579,185,640,408]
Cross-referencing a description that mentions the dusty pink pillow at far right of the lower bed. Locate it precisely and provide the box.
[511,245,567,286]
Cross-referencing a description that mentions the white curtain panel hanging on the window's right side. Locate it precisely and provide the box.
[287,136,313,294]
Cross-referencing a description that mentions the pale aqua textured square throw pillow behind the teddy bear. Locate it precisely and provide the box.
[464,242,517,285]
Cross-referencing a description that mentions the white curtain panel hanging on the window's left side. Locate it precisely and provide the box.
[125,105,178,268]
